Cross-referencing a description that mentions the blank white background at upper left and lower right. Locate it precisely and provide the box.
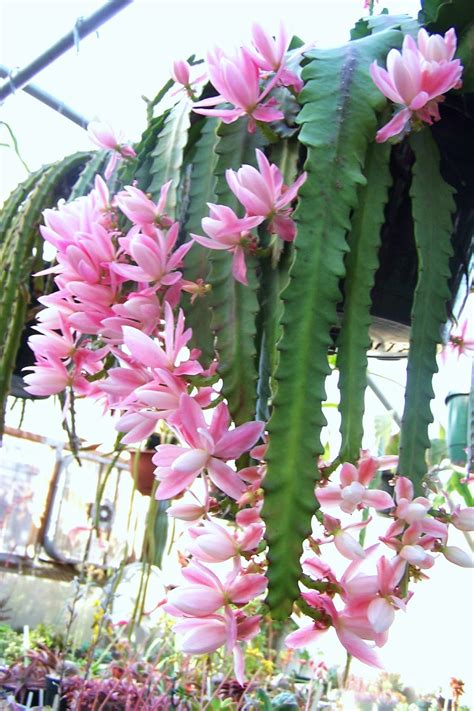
[0,0,473,708]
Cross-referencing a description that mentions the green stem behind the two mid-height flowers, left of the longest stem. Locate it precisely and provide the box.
[209,119,262,424]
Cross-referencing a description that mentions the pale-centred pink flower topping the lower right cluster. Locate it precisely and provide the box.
[316,458,395,514]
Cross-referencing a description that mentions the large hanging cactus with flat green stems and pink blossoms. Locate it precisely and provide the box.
[0,0,474,685]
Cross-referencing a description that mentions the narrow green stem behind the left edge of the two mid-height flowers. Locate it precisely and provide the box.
[182,118,219,366]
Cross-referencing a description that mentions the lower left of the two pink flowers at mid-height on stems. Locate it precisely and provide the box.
[191,203,264,284]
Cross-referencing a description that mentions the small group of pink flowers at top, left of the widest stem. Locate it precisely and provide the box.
[193,25,303,133]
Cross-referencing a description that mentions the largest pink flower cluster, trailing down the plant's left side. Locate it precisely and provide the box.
[25,145,281,683]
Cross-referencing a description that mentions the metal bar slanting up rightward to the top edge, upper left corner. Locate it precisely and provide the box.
[0,0,133,102]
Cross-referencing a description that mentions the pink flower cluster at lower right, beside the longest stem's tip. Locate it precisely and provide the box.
[286,468,474,666]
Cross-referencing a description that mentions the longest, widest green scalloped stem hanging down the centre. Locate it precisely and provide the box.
[262,31,400,618]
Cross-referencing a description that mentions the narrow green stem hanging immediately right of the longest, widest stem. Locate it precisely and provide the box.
[336,143,391,463]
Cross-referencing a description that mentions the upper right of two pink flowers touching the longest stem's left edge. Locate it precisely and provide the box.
[226,149,306,242]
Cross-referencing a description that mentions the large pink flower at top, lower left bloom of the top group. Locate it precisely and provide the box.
[193,48,283,132]
